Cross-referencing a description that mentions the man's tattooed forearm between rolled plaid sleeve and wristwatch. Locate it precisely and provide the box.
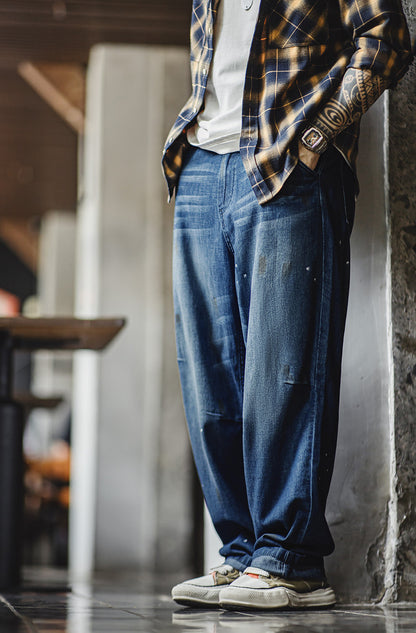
[313,68,387,141]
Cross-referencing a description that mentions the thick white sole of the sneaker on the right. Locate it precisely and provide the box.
[220,587,336,610]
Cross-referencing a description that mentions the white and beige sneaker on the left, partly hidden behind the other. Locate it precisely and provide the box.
[172,565,241,607]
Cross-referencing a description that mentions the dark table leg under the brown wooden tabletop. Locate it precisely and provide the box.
[0,332,23,590]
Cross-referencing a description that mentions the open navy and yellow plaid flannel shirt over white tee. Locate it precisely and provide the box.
[162,0,412,204]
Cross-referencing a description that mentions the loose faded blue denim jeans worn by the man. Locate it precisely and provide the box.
[173,148,354,578]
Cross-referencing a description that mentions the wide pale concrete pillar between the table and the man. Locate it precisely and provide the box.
[70,45,192,574]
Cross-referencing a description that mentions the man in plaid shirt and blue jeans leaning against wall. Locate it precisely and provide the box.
[163,0,411,609]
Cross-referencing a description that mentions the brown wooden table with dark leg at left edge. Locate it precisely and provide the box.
[0,317,125,590]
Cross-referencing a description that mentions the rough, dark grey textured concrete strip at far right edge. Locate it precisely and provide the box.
[389,0,416,600]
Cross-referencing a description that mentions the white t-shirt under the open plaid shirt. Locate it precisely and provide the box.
[188,0,260,154]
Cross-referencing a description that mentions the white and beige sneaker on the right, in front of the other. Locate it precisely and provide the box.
[219,567,335,609]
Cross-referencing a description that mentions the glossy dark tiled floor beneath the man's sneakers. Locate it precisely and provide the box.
[0,571,416,633]
